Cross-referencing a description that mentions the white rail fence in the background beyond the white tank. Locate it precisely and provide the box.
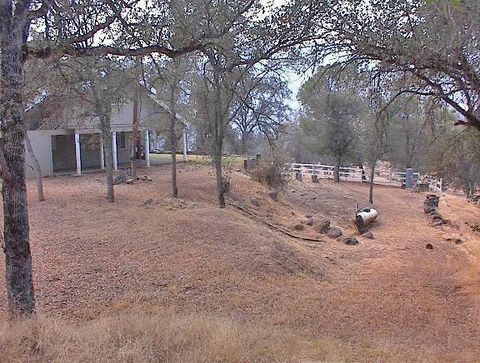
[288,163,443,192]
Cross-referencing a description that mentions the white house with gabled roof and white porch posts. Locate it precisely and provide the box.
[25,89,187,177]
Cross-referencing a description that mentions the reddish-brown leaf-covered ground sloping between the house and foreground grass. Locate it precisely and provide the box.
[0,165,480,362]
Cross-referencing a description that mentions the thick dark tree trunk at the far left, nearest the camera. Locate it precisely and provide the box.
[0,12,35,318]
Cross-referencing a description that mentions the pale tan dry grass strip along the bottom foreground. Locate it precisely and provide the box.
[0,312,344,362]
